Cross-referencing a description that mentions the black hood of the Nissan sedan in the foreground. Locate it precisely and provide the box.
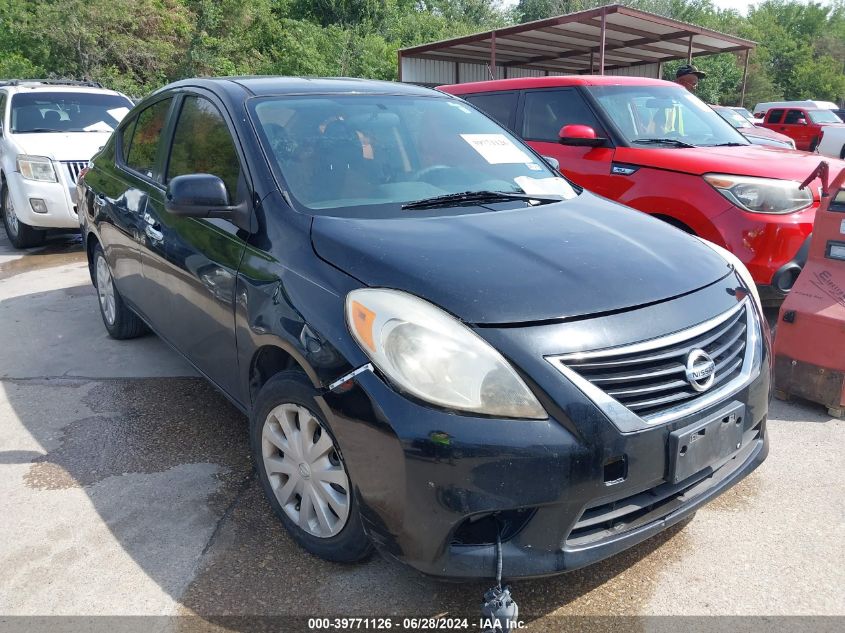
[311,191,729,324]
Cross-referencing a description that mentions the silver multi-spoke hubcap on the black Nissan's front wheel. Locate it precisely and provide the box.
[261,403,350,538]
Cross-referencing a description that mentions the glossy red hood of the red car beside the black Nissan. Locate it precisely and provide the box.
[613,145,845,182]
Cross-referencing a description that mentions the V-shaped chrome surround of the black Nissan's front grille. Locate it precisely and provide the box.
[545,298,763,433]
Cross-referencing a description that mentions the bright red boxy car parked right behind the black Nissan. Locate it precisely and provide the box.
[440,75,845,298]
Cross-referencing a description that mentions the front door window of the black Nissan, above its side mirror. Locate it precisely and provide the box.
[167,96,241,200]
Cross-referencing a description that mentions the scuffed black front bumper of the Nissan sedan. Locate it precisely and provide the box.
[321,278,770,580]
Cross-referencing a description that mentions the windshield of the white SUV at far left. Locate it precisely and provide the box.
[11,91,132,134]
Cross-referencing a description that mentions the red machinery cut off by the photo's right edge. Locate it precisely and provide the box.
[775,162,845,418]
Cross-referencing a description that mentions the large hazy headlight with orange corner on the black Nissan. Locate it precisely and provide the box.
[346,288,548,420]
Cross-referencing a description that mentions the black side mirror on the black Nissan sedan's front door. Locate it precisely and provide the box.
[164,174,257,233]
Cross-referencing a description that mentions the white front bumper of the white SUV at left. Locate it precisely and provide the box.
[8,161,79,229]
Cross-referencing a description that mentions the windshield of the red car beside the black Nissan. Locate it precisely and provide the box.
[588,86,748,147]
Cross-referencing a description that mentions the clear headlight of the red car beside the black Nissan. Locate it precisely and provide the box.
[704,174,813,213]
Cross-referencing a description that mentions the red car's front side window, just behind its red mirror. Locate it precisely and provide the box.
[522,88,606,143]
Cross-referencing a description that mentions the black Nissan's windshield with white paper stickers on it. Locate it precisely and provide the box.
[251,95,576,216]
